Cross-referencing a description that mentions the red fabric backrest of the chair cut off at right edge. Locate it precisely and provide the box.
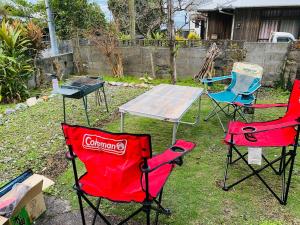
[286,80,300,119]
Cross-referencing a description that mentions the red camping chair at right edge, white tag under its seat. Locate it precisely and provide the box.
[223,80,300,205]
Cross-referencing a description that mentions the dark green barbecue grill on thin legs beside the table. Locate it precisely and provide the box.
[55,76,108,126]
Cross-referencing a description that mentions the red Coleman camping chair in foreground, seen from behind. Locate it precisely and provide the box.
[62,124,195,225]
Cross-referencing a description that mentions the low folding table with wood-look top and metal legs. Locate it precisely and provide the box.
[119,84,203,143]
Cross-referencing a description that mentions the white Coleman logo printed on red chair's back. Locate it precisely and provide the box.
[82,134,127,155]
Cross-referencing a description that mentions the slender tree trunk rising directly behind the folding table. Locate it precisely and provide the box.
[168,0,177,84]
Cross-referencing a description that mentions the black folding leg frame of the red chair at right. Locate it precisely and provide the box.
[223,125,300,205]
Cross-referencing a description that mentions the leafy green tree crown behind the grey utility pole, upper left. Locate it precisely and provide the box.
[0,0,106,39]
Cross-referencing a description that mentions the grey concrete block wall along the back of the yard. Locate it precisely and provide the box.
[74,42,299,86]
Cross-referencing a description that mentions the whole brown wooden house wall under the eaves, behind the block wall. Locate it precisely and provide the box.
[208,7,300,42]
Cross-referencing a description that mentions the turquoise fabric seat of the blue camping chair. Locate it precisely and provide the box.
[208,90,254,104]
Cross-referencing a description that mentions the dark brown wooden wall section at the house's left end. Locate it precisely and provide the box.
[207,12,232,40]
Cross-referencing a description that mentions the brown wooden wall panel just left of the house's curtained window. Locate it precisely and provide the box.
[233,9,260,41]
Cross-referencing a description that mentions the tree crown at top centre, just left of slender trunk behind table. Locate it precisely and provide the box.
[108,0,166,37]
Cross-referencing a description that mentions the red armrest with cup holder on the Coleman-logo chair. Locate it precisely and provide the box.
[142,140,196,173]
